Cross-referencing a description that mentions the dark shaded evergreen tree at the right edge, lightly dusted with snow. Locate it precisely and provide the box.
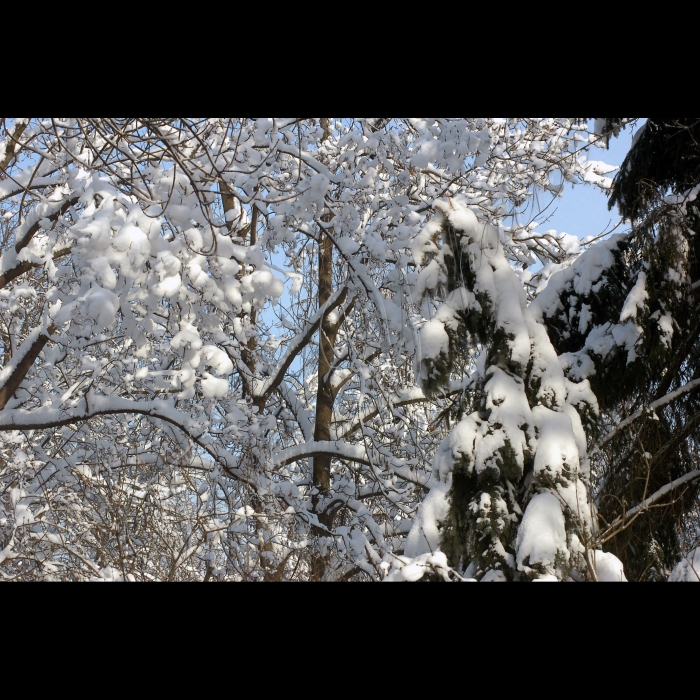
[537,118,700,580]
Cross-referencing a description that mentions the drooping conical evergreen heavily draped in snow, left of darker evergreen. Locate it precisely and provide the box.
[408,200,595,581]
